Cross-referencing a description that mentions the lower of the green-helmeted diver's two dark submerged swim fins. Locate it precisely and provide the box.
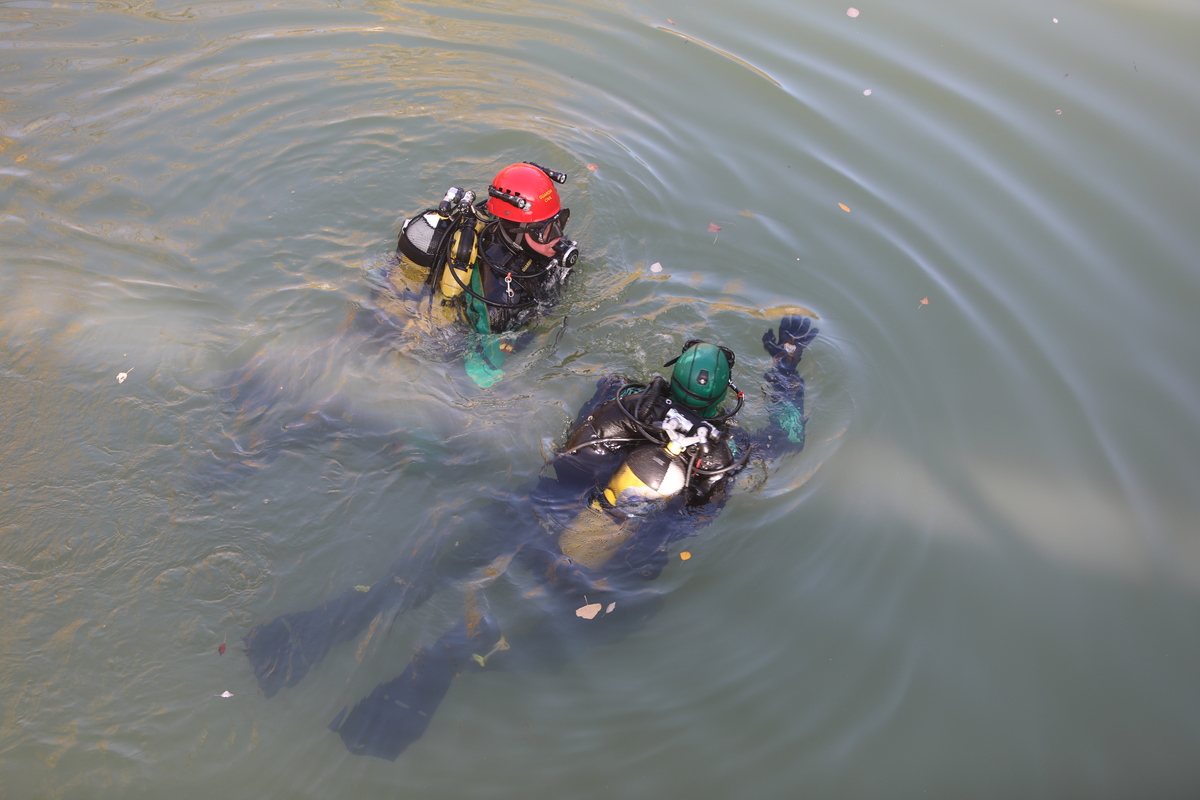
[329,616,500,760]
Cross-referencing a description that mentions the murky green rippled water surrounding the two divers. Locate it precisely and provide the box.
[0,0,1200,800]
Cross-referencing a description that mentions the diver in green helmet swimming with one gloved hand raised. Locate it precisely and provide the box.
[244,317,817,759]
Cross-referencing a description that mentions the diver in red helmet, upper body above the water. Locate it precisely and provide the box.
[388,162,578,386]
